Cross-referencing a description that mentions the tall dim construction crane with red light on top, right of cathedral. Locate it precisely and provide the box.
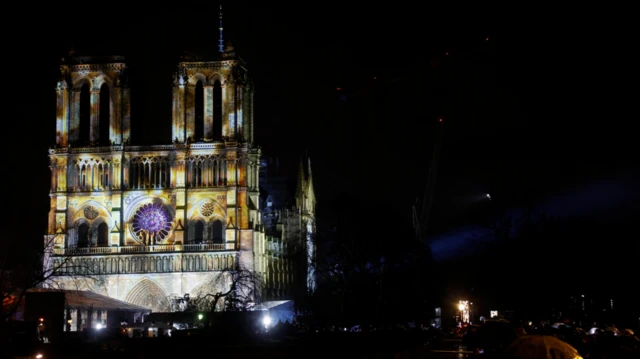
[412,118,444,316]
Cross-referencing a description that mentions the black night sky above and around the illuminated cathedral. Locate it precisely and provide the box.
[3,2,638,266]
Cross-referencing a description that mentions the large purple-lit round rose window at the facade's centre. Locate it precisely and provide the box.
[132,203,171,241]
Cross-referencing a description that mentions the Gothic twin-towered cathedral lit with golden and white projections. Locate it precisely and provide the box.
[44,36,315,311]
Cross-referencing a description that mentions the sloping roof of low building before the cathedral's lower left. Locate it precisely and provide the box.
[29,288,151,313]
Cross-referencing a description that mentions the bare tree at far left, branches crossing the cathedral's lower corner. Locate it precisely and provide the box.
[0,233,103,321]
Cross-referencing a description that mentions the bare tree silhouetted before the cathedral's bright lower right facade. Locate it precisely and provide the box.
[180,265,264,312]
